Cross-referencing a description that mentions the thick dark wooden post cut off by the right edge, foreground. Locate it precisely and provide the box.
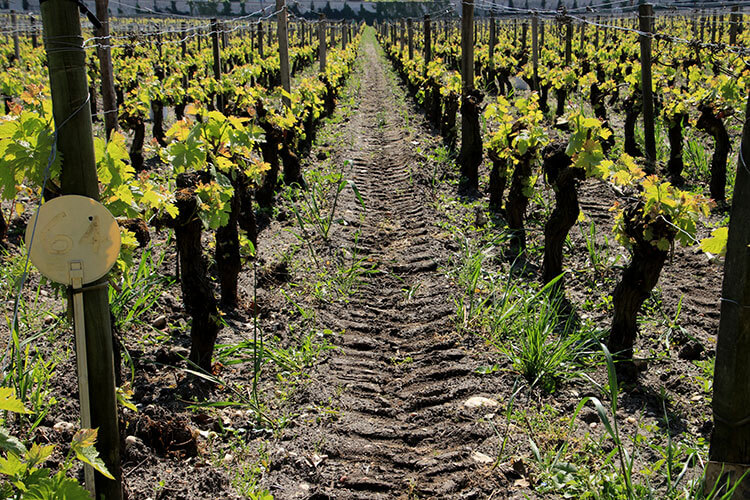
[706,92,750,500]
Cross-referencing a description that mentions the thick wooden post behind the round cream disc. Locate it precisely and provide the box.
[41,0,122,500]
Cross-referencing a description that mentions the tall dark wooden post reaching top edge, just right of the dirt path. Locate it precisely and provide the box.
[459,0,482,190]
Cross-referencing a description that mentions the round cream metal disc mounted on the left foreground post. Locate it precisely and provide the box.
[26,195,120,285]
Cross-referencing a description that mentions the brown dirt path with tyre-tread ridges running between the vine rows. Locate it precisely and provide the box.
[269,31,512,499]
